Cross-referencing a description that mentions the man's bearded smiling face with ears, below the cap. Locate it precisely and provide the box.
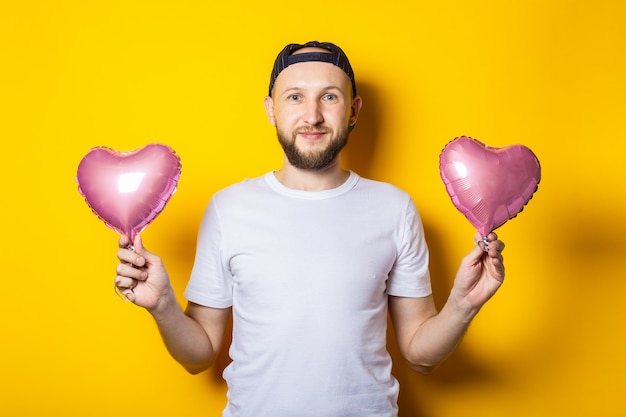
[265,48,361,170]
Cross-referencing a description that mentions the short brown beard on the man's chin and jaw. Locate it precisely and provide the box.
[276,129,349,171]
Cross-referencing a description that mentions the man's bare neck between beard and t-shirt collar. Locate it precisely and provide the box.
[274,160,350,191]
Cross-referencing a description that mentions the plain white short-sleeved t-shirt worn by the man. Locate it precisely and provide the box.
[185,172,431,417]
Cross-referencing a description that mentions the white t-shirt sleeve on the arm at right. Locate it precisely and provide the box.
[387,199,432,297]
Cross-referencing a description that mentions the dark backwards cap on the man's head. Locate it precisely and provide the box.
[269,41,356,97]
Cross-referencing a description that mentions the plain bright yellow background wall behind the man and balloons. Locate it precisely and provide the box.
[0,0,626,417]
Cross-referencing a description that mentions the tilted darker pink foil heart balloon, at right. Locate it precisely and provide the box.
[439,136,541,236]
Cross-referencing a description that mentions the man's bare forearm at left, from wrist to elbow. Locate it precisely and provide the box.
[150,291,216,374]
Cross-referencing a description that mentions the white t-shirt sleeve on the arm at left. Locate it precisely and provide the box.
[184,198,233,308]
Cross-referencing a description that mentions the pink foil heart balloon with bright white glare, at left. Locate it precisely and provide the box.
[76,144,181,242]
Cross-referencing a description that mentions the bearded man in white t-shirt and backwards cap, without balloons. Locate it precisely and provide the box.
[116,42,504,417]
